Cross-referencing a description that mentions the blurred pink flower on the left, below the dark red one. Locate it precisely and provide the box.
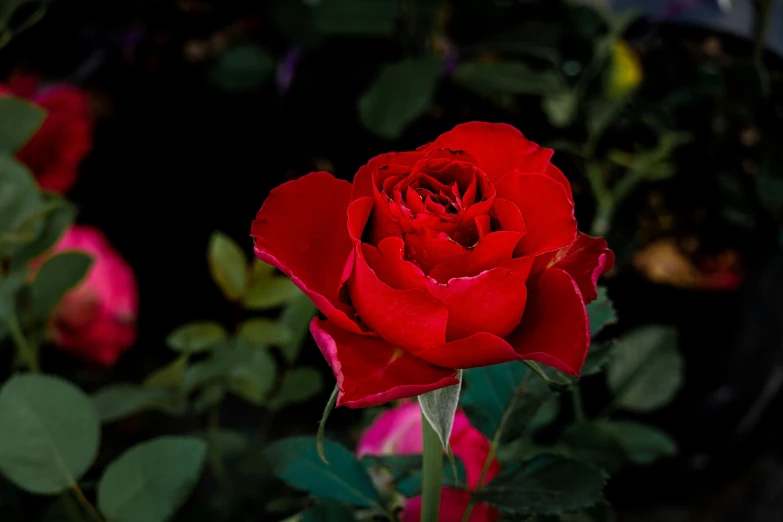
[39,225,138,366]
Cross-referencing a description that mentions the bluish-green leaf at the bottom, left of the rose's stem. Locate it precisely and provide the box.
[264,437,380,507]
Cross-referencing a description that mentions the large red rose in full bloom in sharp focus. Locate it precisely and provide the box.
[251,122,614,407]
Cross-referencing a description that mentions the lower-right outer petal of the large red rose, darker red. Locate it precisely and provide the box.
[507,268,590,376]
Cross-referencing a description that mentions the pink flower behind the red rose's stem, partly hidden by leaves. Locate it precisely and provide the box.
[357,401,500,522]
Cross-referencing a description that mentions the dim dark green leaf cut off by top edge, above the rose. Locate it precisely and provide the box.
[313,0,399,36]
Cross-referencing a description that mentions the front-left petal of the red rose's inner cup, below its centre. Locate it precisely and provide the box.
[349,244,448,350]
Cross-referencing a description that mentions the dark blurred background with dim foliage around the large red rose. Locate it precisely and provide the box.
[0,0,783,522]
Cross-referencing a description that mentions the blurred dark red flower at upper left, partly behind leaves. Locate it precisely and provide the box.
[0,75,93,194]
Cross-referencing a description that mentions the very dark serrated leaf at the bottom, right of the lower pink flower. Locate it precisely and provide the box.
[474,455,606,515]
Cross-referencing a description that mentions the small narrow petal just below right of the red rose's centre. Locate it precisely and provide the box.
[429,231,522,284]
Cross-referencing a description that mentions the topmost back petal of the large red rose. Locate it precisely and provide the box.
[427,121,573,200]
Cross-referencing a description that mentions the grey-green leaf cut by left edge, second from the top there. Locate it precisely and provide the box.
[0,155,43,242]
